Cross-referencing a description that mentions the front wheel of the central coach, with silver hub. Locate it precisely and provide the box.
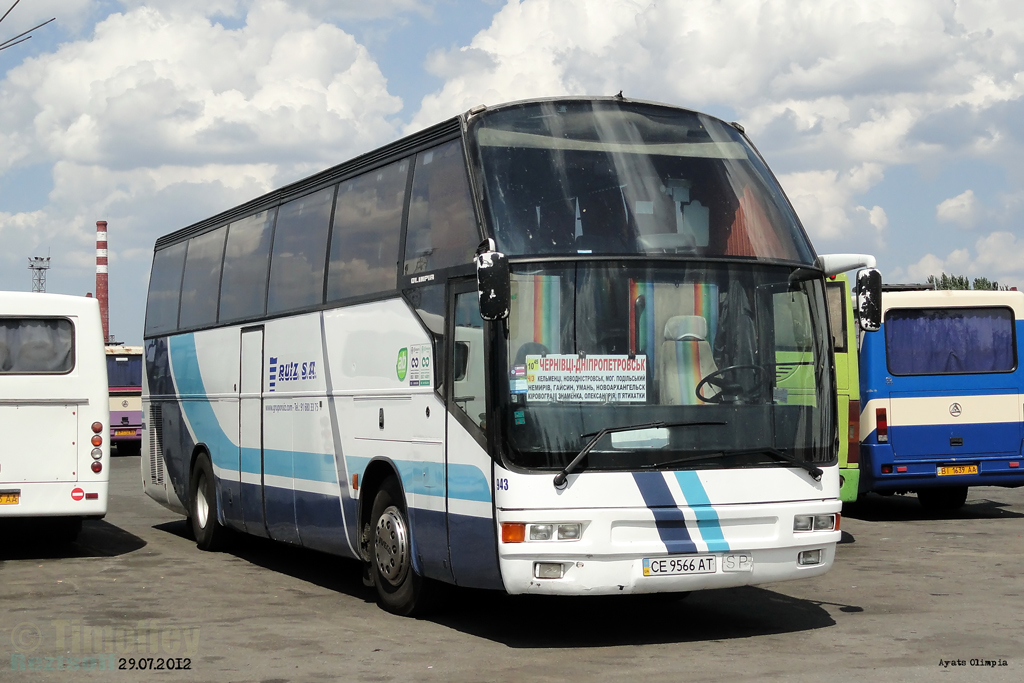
[370,477,435,616]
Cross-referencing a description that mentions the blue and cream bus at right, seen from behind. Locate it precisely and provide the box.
[860,290,1024,511]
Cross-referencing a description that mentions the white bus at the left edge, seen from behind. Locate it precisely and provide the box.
[0,292,110,541]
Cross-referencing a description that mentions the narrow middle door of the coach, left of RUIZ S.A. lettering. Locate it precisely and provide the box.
[239,327,268,537]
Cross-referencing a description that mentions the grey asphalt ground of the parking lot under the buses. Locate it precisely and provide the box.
[0,450,1024,683]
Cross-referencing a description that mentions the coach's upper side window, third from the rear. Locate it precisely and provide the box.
[220,209,276,322]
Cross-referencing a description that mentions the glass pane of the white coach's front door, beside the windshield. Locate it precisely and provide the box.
[452,292,487,428]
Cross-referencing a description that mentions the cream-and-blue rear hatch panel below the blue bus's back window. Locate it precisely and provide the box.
[889,390,1022,458]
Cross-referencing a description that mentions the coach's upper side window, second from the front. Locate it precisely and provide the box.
[327,160,409,301]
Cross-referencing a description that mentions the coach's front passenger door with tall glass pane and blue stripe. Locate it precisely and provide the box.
[444,280,502,588]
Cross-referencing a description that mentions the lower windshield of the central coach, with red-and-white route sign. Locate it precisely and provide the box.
[502,262,836,469]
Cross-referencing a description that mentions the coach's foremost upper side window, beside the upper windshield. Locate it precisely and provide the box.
[404,140,480,275]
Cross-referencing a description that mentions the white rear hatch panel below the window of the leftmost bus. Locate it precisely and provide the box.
[0,404,79,483]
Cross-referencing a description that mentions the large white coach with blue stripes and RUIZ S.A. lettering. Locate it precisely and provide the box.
[142,98,877,614]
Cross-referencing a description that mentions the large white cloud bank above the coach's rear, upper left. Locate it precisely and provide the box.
[0,0,407,341]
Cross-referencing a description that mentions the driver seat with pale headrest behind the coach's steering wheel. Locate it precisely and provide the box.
[657,315,719,405]
